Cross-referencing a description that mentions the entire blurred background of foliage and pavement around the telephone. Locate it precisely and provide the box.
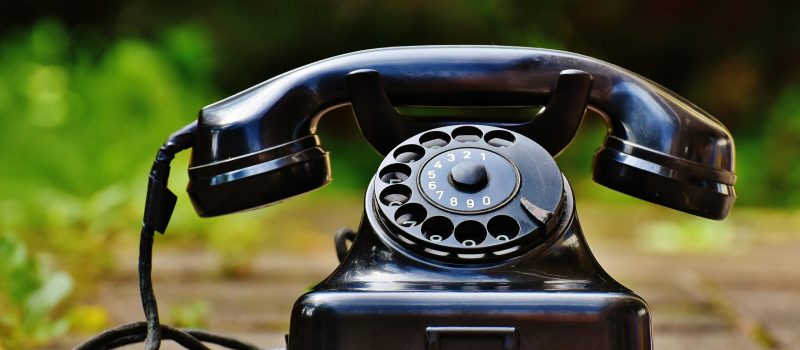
[0,0,800,349]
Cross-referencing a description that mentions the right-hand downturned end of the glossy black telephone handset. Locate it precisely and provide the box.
[592,81,736,220]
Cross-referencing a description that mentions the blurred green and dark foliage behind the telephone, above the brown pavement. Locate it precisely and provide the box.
[0,0,800,348]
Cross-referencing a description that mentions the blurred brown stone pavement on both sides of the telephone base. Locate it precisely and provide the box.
[55,206,800,350]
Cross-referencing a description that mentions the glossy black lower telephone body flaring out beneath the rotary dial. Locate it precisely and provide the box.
[288,179,651,350]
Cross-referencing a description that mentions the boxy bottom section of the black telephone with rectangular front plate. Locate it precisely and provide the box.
[288,290,651,350]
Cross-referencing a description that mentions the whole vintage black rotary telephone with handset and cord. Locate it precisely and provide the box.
[76,46,736,350]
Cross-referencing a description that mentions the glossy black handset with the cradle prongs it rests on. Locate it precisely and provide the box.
[190,46,735,219]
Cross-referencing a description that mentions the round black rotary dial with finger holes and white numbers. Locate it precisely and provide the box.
[373,124,565,264]
